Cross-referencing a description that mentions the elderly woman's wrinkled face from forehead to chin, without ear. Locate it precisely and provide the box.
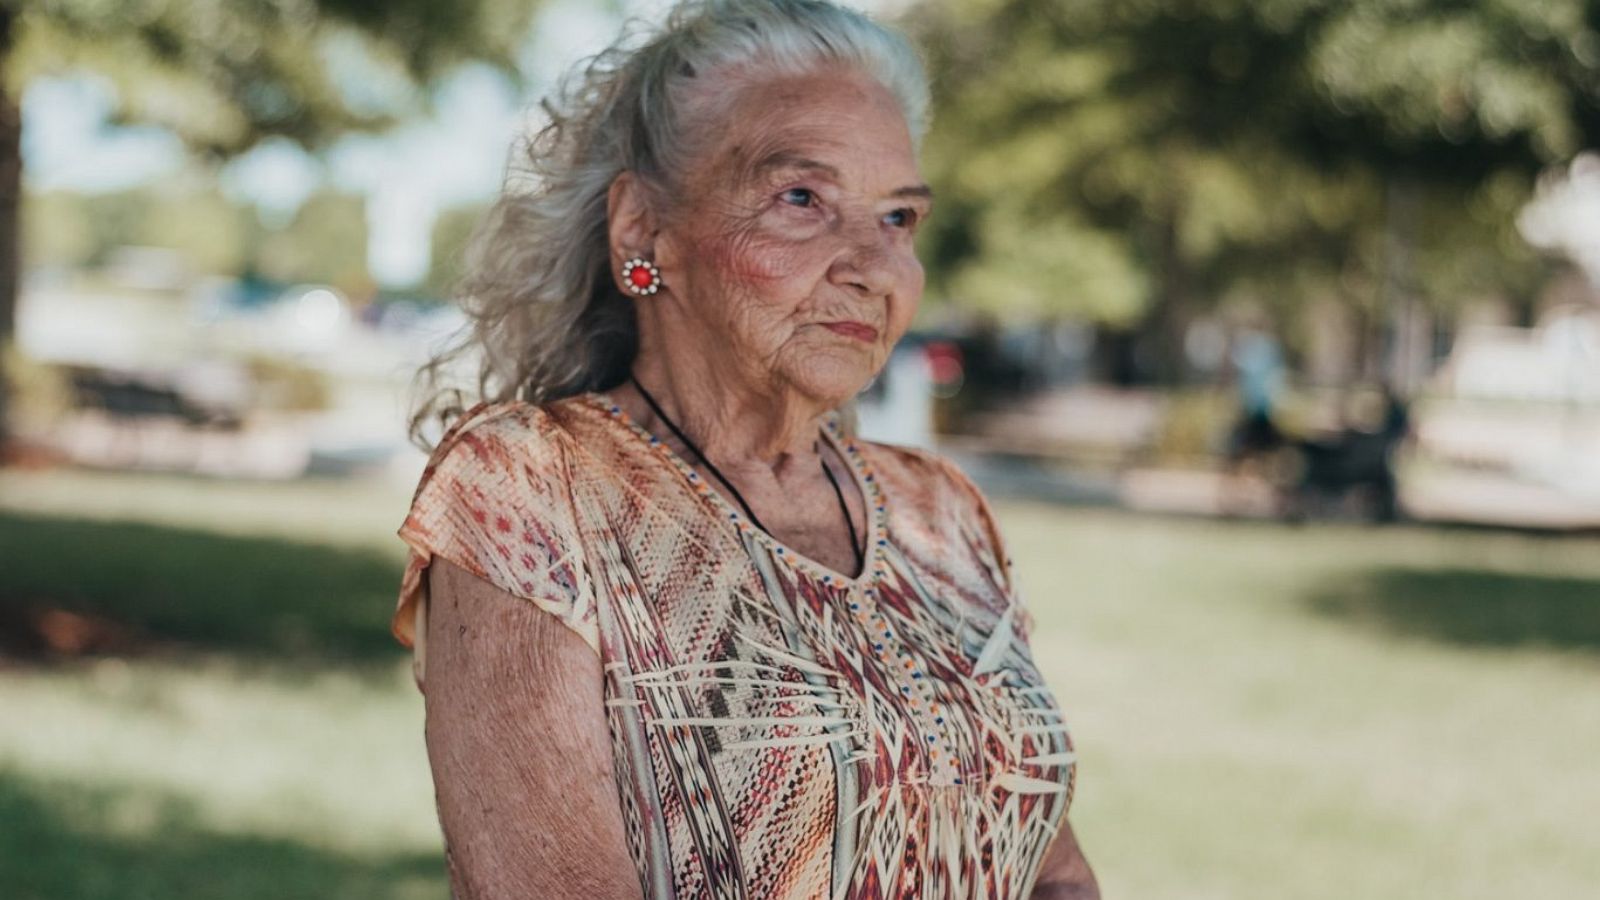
[646,65,930,405]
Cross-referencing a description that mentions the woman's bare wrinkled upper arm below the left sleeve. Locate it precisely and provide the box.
[424,559,642,900]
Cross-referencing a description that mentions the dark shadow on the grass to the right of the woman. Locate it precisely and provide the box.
[1309,569,1600,653]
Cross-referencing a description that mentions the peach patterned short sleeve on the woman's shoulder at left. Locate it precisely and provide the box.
[390,400,600,669]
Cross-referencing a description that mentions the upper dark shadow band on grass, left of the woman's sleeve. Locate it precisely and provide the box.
[0,512,405,661]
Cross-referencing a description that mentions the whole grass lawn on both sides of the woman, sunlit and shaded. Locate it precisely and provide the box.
[0,472,1600,900]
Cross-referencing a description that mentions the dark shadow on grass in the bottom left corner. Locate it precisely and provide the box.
[0,770,450,900]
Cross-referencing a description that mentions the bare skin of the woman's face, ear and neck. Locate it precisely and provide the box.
[610,70,931,573]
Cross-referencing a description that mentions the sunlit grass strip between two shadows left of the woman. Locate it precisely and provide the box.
[0,655,438,852]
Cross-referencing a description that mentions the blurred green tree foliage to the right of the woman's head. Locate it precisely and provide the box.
[912,0,1600,378]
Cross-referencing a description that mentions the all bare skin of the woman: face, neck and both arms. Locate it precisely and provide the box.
[427,63,1099,900]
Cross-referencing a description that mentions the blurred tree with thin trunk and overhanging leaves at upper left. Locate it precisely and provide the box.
[0,0,538,444]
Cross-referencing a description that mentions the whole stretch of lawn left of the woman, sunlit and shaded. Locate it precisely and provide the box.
[0,472,435,898]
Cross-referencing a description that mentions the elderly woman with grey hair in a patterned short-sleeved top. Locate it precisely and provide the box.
[394,0,1098,898]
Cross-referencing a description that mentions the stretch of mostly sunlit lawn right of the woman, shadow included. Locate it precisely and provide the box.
[1002,504,1600,900]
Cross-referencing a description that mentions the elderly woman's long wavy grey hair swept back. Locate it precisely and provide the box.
[408,0,928,450]
